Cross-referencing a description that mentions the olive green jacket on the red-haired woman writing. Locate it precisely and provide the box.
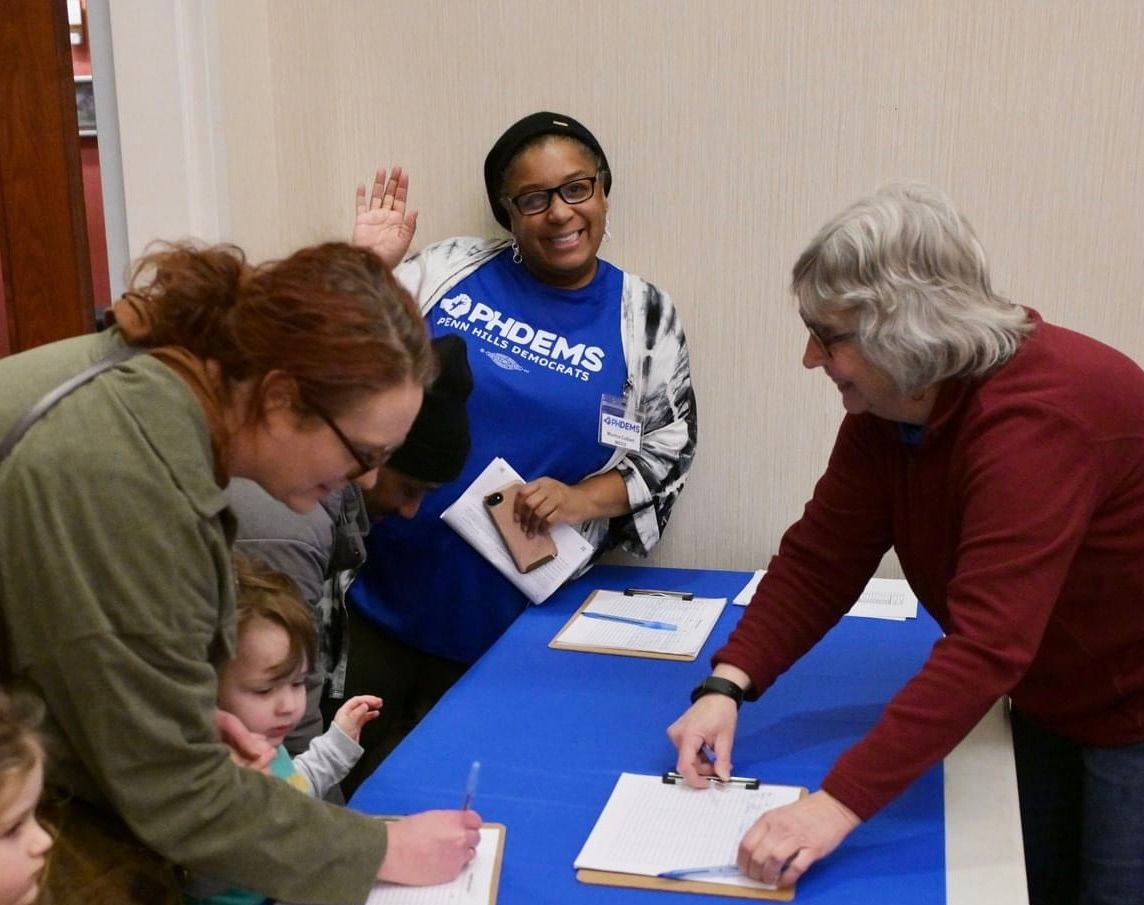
[0,332,386,905]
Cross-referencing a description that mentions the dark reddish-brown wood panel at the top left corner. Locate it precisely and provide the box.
[0,0,94,351]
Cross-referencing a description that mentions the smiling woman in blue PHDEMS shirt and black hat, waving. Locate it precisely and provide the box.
[345,112,697,787]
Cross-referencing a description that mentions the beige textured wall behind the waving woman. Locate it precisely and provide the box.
[196,0,1144,573]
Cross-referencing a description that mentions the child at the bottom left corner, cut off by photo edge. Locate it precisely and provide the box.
[0,691,51,905]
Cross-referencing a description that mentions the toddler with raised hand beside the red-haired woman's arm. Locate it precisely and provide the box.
[186,557,381,905]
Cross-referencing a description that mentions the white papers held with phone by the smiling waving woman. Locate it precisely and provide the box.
[440,457,593,603]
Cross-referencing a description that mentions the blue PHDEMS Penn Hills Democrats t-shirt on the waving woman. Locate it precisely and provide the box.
[350,249,627,662]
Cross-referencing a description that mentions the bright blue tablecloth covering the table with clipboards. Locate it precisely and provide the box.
[351,566,945,905]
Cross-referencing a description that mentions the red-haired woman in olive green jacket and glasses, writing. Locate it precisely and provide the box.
[0,244,479,905]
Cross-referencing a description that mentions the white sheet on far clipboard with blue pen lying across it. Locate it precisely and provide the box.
[559,590,726,657]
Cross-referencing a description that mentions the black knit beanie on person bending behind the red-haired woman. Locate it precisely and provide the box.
[386,334,472,484]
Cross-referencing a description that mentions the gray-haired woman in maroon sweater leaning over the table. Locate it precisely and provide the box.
[668,184,1144,905]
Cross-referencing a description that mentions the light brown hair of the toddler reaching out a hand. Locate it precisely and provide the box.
[235,556,318,678]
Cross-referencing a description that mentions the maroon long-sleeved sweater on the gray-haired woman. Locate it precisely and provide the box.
[714,312,1144,819]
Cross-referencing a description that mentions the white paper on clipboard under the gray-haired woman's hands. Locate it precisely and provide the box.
[574,773,800,889]
